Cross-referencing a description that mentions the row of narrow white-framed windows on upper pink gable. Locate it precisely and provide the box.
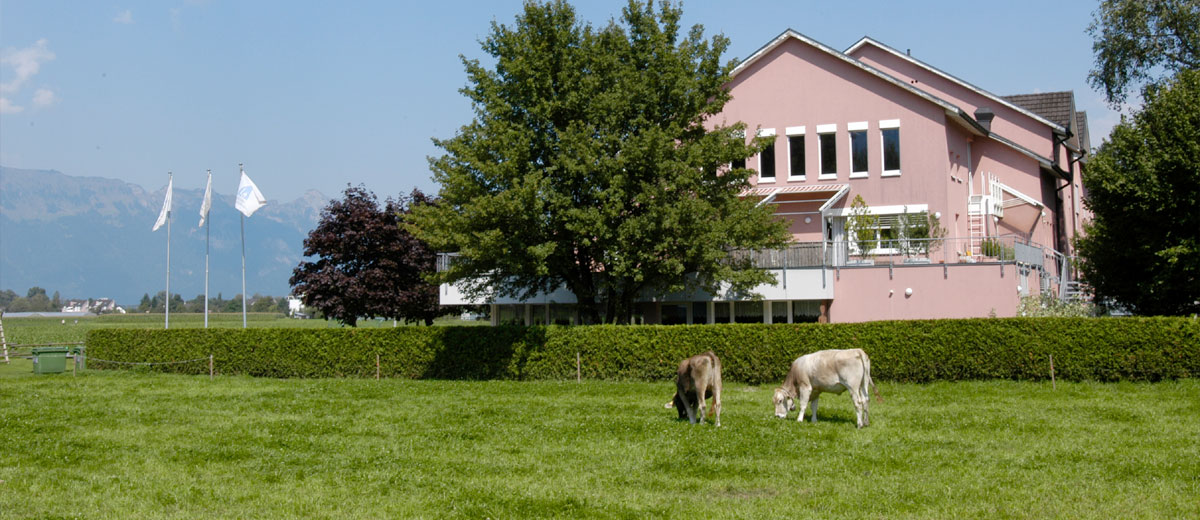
[732,119,900,183]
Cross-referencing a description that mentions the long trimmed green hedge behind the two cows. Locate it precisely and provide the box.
[86,318,1200,384]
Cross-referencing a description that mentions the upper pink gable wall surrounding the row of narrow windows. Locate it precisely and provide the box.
[712,38,965,240]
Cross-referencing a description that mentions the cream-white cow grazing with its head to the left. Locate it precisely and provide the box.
[772,348,875,428]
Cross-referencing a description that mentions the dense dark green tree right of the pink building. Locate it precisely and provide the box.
[1076,71,1200,315]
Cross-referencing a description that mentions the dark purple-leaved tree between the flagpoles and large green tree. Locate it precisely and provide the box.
[289,186,439,327]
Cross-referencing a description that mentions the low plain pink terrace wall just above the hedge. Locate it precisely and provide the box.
[829,264,1034,323]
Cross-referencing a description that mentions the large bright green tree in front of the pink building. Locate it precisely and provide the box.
[410,1,786,323]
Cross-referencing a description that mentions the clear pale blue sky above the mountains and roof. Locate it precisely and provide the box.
[0,0,1118,201]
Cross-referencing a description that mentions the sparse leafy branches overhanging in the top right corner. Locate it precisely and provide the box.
[1087,0,1200,106]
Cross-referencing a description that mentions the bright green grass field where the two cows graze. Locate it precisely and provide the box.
[0,371,1200,519]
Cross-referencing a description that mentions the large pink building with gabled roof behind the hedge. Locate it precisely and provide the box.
[442,30,1090,323]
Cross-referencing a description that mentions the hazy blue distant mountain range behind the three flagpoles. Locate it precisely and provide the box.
[0,166,330,305]
